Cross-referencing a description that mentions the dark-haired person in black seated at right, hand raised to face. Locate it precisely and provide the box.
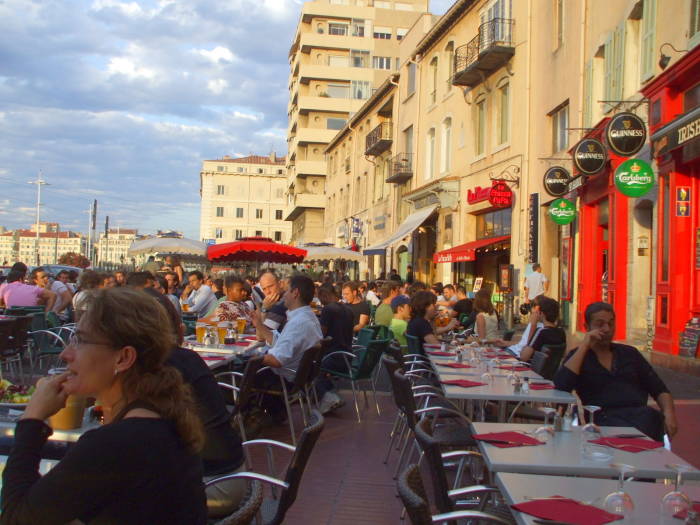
[554,303,678,441]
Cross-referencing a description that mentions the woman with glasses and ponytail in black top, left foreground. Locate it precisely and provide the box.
[0,288,207,525]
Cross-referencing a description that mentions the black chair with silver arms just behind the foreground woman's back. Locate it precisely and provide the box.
[206,410,324,525]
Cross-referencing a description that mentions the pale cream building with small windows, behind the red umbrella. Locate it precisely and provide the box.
[199,153,292,244]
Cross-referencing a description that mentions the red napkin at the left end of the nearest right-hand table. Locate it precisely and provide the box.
[511,496,623,525]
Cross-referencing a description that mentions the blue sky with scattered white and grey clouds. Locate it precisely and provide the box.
[0,0,453,238]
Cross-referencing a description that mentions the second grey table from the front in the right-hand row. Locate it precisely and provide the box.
[471,423,700,479]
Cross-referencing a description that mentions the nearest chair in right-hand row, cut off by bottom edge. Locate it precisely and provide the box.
[396,465,512,525]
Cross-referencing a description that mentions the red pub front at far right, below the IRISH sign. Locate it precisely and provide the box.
[642,47,700,356]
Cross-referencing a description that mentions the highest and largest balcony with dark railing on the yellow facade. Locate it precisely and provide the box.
[452,18,515,87]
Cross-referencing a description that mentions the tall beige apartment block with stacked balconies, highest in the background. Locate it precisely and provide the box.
[284,0,428,244]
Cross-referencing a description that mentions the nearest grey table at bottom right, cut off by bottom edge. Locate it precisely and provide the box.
[495,473,700,525]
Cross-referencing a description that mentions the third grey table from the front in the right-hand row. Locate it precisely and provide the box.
[440,368,576,422]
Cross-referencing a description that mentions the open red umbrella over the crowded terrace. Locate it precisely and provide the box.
[207,237,306,263]
